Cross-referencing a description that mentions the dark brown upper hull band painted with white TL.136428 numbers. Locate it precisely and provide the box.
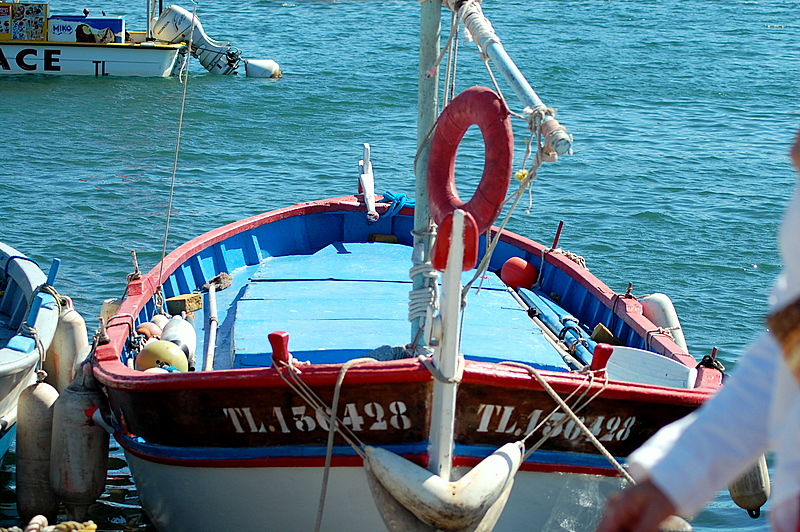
[109,359,705,475]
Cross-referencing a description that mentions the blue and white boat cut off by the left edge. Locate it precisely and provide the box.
[0,243,61,456]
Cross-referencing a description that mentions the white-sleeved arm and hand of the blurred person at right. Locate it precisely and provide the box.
[597,333,781,532]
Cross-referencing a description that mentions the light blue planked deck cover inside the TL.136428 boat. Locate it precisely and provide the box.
[202,243,569,371]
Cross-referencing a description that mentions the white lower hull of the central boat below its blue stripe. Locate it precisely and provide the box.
[126,453,622,532]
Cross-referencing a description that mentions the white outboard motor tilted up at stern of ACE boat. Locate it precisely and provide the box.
[153,5,281,78]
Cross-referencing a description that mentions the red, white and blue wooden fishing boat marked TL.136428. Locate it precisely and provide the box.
[92,1,722,532]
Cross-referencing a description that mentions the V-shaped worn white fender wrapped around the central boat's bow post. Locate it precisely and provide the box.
[364,442,522,530]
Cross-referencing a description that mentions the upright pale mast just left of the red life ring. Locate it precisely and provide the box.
[411,0,442,345]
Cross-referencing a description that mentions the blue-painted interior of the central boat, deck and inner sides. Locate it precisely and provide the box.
[133,211,648,371]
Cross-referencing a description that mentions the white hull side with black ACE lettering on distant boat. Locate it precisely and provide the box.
[0,41,184,77]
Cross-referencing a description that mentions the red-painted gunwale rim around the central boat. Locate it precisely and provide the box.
[94,196,722,405]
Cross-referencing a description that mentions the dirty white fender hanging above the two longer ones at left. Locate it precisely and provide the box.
[42,298,89,393]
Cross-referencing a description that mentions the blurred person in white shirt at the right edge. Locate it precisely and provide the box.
[596,133,800,532]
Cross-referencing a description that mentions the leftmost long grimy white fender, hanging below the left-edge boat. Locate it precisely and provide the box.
[16,382,58,523]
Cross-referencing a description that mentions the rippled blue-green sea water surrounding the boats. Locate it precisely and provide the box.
[0,0,800,531]
